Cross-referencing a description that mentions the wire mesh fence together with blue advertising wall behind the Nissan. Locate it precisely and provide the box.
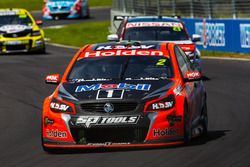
[111,0,250,53]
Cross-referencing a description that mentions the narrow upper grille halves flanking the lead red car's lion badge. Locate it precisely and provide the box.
[81,102,138,112]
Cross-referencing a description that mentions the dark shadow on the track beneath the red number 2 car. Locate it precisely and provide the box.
[45,130,231,154]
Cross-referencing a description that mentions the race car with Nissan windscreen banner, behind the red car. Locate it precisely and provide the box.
[108,16,201,68]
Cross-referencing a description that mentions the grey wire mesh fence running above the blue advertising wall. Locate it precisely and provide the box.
[112,0,250,18]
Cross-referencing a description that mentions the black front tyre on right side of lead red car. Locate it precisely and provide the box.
[184,103,192,143]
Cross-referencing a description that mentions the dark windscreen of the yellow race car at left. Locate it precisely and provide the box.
[0,15,32,26]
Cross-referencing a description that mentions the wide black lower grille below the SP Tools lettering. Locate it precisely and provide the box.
[71,127,148,144]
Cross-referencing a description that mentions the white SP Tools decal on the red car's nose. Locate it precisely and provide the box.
[75,116,140,128]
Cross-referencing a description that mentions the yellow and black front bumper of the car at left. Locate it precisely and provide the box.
[0,36,45,54]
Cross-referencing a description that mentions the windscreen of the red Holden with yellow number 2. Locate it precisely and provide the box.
[68,56,173,82]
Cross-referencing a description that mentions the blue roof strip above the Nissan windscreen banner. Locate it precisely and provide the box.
[128,16,181,23]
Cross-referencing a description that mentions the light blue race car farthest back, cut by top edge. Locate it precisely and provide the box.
[42,0,89,20]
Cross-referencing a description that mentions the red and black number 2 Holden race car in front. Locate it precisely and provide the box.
[41,42,208,152]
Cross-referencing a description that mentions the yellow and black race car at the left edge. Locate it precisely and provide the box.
[0,9,45,54]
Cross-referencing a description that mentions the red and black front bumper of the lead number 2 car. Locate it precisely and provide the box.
[43,110,183,148]
